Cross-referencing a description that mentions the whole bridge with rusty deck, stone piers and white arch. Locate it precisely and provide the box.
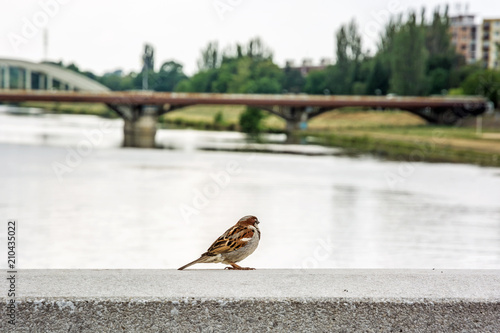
[0,59,488,147]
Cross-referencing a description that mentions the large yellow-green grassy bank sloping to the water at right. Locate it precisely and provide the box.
[305,111,500,167]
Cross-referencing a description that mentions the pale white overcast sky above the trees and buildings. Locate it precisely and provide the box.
[0,0,500,74]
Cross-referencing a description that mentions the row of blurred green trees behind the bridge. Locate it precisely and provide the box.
[61,7,500,105]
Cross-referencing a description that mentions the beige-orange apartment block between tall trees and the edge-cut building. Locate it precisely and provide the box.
[450,15,480,64]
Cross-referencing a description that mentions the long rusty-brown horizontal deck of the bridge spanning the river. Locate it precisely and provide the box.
[0,90,487,109]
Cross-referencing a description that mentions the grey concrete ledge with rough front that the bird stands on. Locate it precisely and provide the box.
[0,269,500,332]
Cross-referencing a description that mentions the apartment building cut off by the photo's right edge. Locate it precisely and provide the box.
[481,19,500,69]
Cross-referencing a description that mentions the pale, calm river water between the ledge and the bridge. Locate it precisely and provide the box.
[0,107,500,269]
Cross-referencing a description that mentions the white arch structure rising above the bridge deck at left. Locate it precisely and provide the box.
[0,58,109,92]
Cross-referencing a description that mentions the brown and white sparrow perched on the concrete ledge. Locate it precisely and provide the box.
[179,215,260,270]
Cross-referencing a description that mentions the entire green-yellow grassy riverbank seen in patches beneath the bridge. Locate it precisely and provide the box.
[17,103,500,167]
